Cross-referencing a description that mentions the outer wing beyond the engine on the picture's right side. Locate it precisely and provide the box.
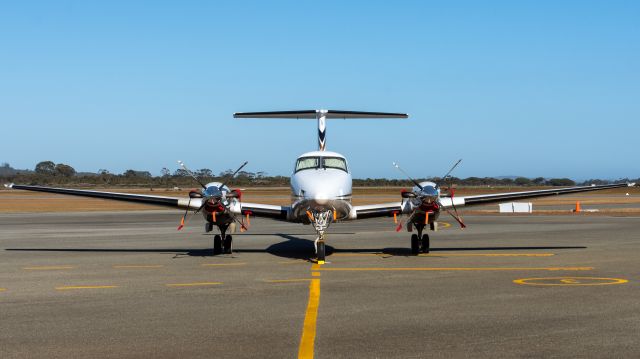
[452,183,635,207]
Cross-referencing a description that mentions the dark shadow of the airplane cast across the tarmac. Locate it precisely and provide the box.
[5,233,587,260]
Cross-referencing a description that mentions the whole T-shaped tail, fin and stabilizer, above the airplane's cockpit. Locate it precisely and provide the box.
[233,110,409,151]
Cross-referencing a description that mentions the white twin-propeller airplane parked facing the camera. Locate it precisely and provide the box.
[5,110,635,263]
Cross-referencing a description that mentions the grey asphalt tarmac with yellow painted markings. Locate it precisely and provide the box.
[0,211,640,358]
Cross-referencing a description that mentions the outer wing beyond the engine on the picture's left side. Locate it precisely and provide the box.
[5,183,202,209]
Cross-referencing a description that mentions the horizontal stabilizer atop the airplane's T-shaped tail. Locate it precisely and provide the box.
[233,110,409,119]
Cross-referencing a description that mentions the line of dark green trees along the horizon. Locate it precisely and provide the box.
[0,161,640,188]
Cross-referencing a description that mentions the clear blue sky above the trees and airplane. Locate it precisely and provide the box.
[0,1,640,179]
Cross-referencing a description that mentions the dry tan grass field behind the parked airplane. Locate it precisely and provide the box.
[0,187,640,215]
